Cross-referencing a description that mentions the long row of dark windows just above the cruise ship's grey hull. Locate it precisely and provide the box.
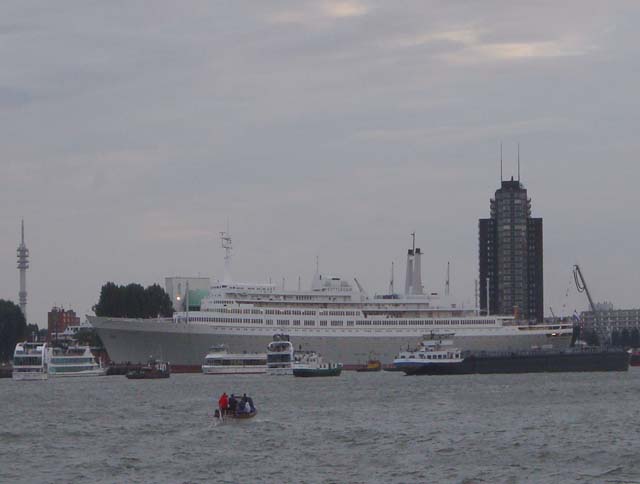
[182,316,493,327]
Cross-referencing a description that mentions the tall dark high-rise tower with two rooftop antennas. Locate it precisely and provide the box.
[479,176,544,321]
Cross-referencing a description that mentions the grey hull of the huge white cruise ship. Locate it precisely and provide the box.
[89,316,571,372]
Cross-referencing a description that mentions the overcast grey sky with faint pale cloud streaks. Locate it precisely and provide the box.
[0,0,640,326]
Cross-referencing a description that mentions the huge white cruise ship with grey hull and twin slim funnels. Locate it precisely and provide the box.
[88,233,573,371]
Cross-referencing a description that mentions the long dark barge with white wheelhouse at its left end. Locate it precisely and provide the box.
[393,334,629,375]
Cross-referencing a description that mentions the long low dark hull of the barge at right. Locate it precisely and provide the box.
[395,351,629,375]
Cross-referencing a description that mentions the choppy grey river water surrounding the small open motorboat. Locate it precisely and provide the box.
[0,368,640,484]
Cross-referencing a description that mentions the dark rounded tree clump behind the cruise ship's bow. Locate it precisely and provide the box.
[93,282,173,318]
